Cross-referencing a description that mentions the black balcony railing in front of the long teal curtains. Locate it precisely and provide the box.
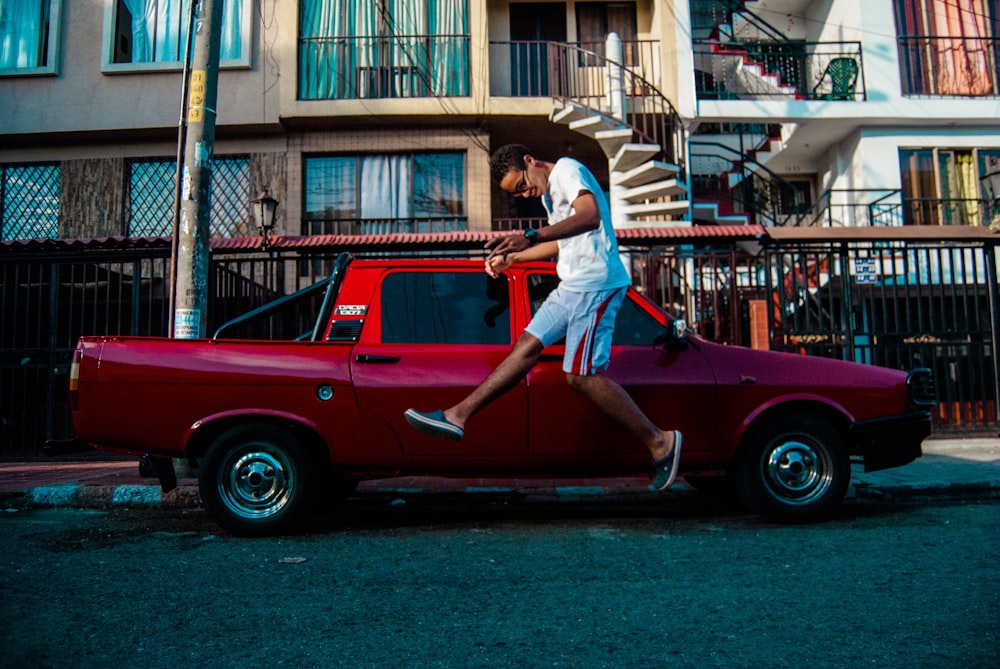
[299,35,470,100]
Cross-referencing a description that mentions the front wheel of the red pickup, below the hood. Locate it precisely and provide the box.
[735,414,851,522]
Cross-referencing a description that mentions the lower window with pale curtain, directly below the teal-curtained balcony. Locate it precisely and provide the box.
[302,152,466,235]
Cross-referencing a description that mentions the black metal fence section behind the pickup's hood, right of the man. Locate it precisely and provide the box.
[633,242,1000,434]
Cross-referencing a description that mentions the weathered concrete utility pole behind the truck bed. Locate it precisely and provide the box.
[173,0,222,339]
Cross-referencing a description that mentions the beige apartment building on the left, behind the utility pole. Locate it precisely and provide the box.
[0,0,690,240]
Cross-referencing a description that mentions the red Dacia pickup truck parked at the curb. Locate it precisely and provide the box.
[70,254,935,534]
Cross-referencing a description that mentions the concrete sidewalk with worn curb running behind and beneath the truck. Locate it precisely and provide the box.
[0,437,1000,508]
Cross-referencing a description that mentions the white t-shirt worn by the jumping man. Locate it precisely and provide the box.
[542,158,632,292]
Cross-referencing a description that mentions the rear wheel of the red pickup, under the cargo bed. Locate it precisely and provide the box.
[198,423,318,536]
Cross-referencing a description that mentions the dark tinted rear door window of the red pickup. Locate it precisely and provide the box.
[381,272,510,346]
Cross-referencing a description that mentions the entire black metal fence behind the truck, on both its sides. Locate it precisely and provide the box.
[0,235,1000,460]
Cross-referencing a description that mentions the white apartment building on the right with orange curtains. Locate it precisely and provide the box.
[678,0,1000,226]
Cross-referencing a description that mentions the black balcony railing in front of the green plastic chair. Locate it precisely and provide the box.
[694,40,866,100]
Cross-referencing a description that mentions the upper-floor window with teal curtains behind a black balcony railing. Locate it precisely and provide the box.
[299,0,469,100]
